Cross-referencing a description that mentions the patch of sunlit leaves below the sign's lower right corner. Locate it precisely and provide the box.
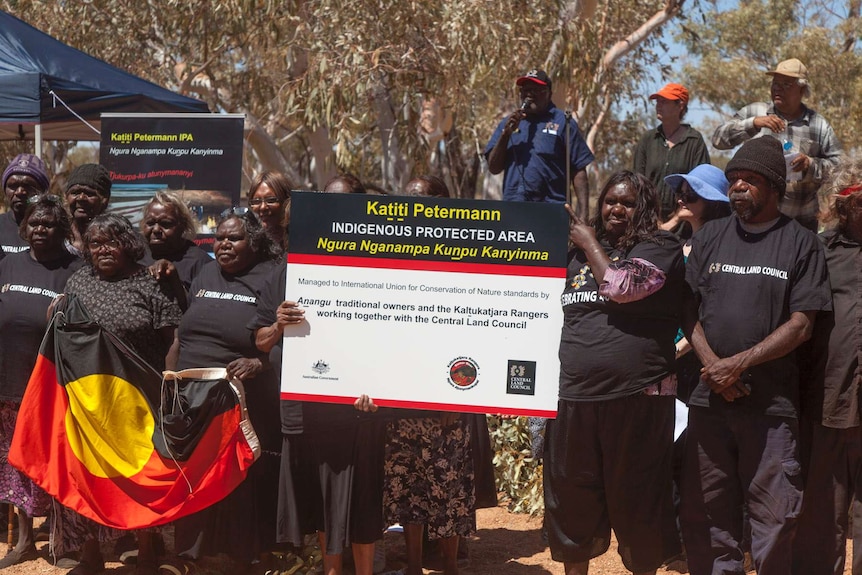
[488,416,545,515]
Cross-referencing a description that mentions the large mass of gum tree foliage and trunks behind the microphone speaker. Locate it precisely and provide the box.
[0,0,681,191]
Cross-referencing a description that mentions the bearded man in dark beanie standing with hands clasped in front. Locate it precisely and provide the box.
[680,138,831,575]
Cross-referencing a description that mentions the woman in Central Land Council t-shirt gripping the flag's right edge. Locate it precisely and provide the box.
[174,208,280,565]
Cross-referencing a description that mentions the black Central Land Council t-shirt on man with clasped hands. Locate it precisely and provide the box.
[686,215,832,417]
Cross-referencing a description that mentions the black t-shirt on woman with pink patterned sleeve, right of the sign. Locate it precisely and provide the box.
[560,232,685,401]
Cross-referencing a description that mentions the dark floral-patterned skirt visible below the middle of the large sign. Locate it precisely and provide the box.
[383,417,476,539]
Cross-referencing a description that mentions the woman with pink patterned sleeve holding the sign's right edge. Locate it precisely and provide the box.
[544,172,685,575]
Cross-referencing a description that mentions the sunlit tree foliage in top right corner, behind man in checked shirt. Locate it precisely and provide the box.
[678,0,862,151]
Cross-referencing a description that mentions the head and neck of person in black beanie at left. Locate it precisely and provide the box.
[66,164,111,253]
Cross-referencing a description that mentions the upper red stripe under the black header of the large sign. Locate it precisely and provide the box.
[287,254,566,278]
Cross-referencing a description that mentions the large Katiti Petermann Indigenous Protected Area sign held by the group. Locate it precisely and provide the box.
[282,193,568,417]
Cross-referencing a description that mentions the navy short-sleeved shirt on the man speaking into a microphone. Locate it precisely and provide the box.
[485,104,594,203]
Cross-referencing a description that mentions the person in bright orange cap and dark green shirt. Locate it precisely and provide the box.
[633,84,709,221]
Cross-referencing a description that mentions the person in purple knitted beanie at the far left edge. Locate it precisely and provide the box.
[0,154,49,254]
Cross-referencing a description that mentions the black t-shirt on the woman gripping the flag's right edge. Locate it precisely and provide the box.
[178,261,281,451]
